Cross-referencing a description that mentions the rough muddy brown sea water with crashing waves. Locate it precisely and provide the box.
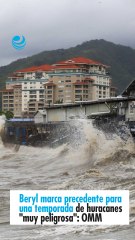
[0,116,135,240]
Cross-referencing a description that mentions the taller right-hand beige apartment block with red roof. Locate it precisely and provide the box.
[44,57,111,104]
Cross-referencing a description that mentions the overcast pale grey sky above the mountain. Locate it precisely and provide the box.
[0,0,135,66]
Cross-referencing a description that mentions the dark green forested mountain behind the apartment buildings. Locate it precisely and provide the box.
[0,39,135,92]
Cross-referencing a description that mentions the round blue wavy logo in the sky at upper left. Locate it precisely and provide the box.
[12,36,26,50]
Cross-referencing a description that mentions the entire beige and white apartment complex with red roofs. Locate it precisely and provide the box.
[2,57,115,117]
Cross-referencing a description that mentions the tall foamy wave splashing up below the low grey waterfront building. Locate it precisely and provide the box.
[63,120,135,168]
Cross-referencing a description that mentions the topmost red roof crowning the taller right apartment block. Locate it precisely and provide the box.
[56,57,103,65]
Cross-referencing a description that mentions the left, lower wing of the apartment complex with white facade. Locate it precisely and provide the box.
[2,65,52,117]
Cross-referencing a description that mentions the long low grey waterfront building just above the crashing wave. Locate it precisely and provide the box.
[34,96,135,123]
